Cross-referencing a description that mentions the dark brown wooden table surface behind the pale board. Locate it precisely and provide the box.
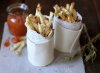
[0,0,100,73]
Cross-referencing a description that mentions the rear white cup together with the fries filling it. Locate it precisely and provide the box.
[53,3,83,54]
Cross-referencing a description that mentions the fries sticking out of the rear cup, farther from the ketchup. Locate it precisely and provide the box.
[53,2,80,23]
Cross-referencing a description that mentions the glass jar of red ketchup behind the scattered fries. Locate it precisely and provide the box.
[7,3,28,36]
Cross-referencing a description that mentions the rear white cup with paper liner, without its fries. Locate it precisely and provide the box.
[53,13,83,53]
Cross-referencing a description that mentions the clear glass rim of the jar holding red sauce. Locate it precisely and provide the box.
[7,3,29,13]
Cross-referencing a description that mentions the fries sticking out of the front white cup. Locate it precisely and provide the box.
[25,4,54,38]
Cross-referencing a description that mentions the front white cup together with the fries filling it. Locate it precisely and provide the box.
[25,4,54,66]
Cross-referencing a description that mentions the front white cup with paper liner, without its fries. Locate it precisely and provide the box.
[27,29,54,66]
